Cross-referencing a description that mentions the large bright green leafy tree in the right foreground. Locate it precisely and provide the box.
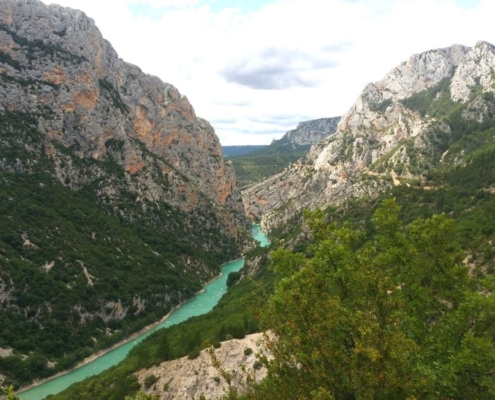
[238,200,495,400]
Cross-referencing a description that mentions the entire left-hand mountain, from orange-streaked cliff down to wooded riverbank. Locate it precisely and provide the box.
[0,0,251,386]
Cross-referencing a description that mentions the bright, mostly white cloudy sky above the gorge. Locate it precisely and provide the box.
[43,0,495,145]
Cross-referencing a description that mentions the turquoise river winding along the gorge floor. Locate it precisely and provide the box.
[17,225,270,400]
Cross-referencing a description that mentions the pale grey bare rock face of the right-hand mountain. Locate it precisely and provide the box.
[243,42,495,230]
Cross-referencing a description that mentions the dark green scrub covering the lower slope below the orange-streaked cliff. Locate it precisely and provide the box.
[0,112,237,387]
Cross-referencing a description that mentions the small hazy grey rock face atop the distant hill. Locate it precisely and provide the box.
[275,117,340,147]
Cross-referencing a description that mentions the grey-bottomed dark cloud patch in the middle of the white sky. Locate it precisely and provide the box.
[220,47,338,90]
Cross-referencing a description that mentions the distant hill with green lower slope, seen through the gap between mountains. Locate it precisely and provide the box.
[230,117,340,187]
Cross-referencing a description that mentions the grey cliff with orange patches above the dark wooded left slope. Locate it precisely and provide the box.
[0,0,250,236]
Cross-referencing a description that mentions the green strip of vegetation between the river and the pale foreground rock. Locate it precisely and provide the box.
[50,248,277,400]
